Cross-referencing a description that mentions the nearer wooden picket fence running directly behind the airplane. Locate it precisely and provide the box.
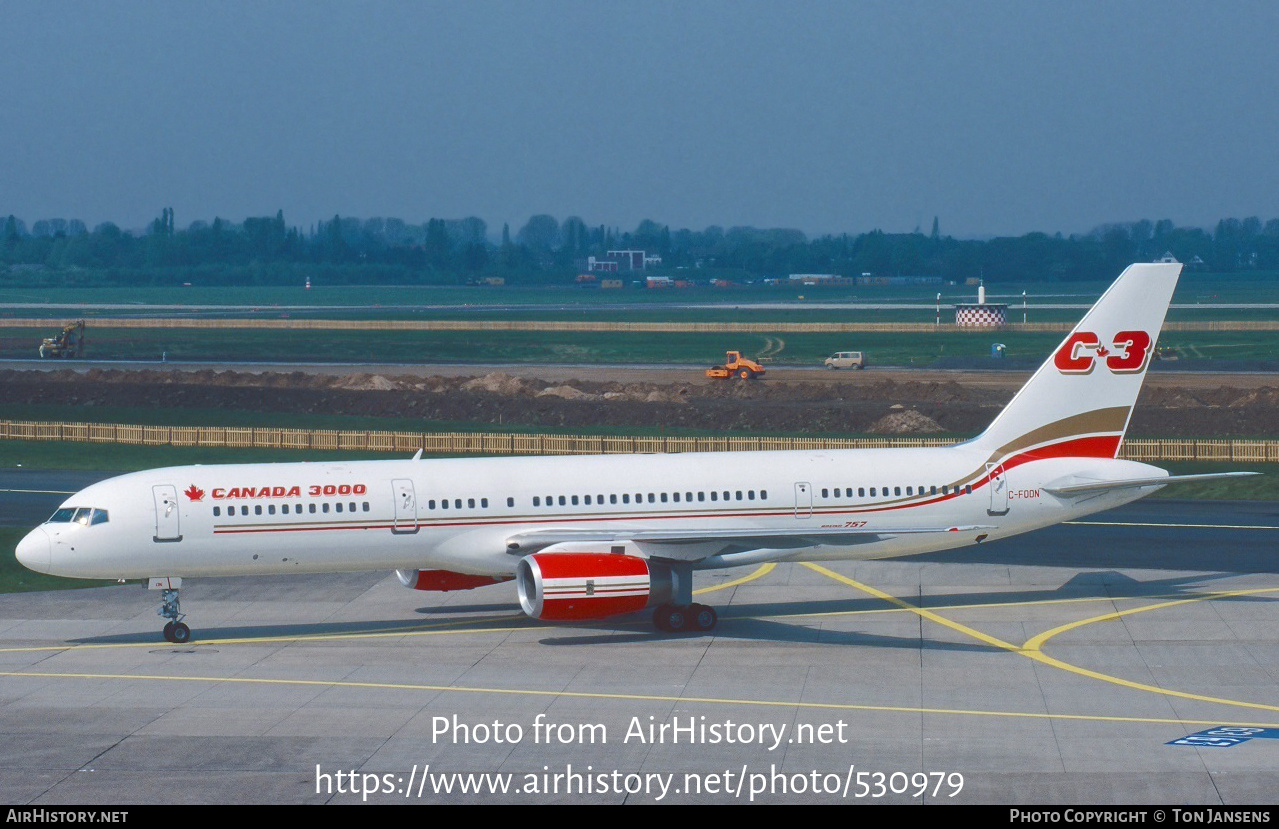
[0,420,1279,463]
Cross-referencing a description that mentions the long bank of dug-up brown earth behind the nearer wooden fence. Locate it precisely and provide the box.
[0,368,1279,438]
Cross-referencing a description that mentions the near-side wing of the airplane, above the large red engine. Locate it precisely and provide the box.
[506,526,990,562]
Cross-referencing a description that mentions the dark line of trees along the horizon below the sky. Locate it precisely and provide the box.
[0,209,1279,285]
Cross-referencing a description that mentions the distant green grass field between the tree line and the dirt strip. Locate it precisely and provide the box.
[0,274,1279,366]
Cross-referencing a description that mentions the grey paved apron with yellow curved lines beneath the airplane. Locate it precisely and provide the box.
[0,473,1279,805]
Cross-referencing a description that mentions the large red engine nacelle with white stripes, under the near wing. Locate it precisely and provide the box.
[515,553,671,622]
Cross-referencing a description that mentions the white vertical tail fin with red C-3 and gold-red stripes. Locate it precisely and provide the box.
[969,262,1182,463]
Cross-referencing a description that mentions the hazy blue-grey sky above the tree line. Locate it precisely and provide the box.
[0,0,1279,235]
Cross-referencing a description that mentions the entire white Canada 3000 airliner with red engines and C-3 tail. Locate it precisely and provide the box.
[17,264,1250,642]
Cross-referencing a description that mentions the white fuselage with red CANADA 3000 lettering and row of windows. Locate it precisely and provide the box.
[18,444,1161,578]
